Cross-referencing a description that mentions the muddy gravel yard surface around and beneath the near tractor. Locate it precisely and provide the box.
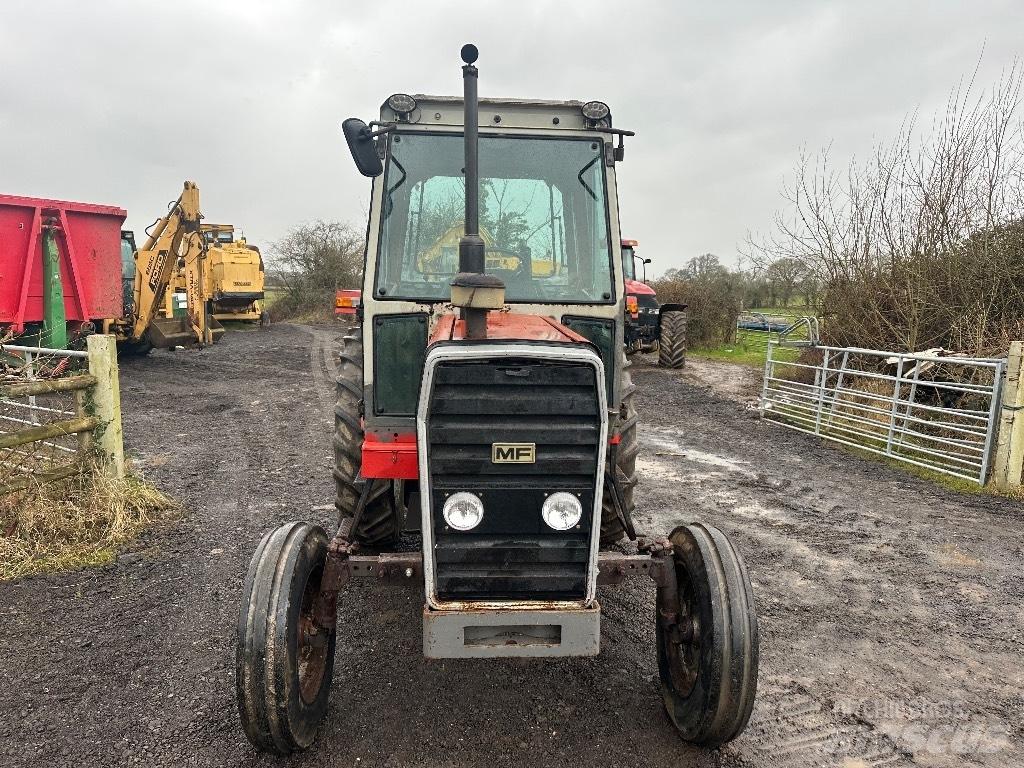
[0,325,1024,768]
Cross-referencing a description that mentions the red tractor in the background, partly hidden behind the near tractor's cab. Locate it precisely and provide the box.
[620,240,686,368]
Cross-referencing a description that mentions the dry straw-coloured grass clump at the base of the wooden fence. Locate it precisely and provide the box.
[0,471,177,581]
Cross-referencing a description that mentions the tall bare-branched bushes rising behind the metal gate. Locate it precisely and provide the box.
[748,63,1024,353]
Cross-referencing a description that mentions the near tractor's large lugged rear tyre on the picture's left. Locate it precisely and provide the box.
[333,326,401,548]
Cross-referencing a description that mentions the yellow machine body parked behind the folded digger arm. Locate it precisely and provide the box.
[163,223,263,323]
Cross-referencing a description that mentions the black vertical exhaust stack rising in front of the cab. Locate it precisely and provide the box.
[452,44,505,339]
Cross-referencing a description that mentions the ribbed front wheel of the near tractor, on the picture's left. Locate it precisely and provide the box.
[236,522,336,755]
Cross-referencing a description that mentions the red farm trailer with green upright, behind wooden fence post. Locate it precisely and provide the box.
[0,195,127,347]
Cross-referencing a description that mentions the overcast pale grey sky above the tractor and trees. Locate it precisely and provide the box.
[0,0,1024,272]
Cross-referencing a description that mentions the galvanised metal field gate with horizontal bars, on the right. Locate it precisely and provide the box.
[760,343,1006,484]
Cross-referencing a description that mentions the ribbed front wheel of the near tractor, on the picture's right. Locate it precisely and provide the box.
[656,523,758,746]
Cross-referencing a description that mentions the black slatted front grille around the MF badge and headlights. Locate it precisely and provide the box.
[426,358,601,600]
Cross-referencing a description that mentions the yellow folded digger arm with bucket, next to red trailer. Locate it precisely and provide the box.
[112,181,224,354]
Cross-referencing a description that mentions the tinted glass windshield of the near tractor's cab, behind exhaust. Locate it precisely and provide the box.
[375,133,614,303]
